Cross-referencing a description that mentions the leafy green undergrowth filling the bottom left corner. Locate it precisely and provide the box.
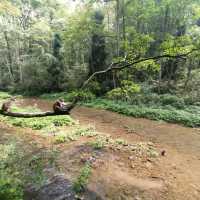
[0,140,58,200]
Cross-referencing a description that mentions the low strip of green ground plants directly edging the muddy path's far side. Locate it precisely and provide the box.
[84,99,200,127]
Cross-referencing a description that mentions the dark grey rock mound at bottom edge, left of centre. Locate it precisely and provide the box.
[24,175,76,200]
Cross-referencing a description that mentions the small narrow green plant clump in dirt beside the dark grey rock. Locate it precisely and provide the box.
[73,164,91,193]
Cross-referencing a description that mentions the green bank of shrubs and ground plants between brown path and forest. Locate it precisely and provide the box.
[39,89,200,127]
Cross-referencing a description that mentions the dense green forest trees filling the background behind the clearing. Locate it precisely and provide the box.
[0,0,200,98]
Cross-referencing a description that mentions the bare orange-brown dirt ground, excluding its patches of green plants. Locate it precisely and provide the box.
[0,99,200,200]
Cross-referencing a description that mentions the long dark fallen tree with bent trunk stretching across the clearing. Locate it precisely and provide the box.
[0,49,199,118]
